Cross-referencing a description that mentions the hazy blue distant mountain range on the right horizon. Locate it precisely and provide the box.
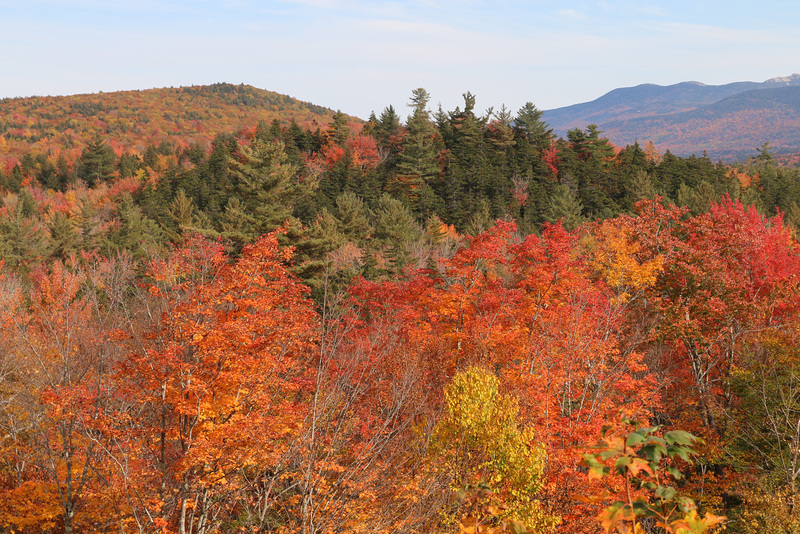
[542,74,800,161]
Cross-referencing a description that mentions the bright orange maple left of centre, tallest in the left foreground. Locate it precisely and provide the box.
[116,233,315,532]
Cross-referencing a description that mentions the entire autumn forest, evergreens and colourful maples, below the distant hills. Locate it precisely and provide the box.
[0,86,800,534]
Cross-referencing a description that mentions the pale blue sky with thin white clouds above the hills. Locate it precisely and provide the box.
[0,0,800,118]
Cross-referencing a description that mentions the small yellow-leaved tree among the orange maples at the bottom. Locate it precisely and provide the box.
[431,367,559,534]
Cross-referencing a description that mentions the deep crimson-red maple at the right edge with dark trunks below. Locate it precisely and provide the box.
[631,198,800,430]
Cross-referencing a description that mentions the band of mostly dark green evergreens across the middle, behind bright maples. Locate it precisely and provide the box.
[0,89,800,285]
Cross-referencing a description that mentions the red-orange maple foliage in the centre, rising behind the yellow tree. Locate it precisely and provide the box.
[346,222,658,532]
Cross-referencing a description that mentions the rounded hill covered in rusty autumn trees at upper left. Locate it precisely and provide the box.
[0,83,346,166]
